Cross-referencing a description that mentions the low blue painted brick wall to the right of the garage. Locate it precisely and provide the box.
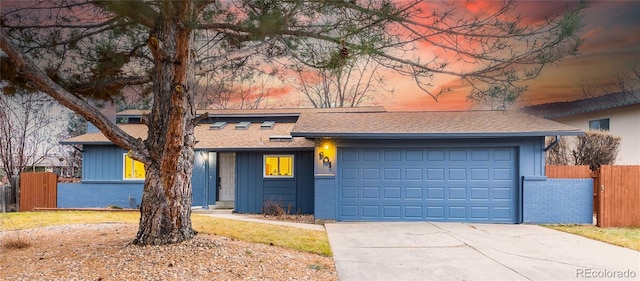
[523,177,593,224]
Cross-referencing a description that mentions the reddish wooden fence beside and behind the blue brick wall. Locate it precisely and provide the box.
[546,165,640,227]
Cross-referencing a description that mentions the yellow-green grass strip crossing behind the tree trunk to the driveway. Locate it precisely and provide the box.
[0,211,331,256]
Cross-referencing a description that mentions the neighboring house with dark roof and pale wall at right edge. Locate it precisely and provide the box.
[522,91,640,165]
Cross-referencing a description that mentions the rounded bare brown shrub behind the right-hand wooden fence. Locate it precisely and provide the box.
[572,131,620,171]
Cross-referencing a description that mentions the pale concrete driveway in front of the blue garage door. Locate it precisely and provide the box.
[325,222,640,281]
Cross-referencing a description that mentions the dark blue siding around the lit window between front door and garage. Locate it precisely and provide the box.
[235,151,314,214]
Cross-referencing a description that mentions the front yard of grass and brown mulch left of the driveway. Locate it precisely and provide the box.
[0,211,338,281]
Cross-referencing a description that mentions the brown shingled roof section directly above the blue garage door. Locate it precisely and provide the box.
[291,111,582,139]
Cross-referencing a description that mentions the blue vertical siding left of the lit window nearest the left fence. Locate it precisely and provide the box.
[82,145,127,182]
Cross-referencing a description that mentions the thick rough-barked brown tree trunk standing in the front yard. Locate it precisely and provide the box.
[131,2,197,245]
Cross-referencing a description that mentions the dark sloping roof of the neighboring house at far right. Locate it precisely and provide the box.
[521,90,640,119]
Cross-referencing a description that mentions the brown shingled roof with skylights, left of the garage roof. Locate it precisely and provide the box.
[60,123,314,150]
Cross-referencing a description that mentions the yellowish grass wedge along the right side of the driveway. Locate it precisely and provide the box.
[545,225,640,251]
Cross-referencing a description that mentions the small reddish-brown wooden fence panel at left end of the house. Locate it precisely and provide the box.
[20,172,58,212]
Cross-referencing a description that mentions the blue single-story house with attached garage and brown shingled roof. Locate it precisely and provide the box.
[58,107,592,223]
